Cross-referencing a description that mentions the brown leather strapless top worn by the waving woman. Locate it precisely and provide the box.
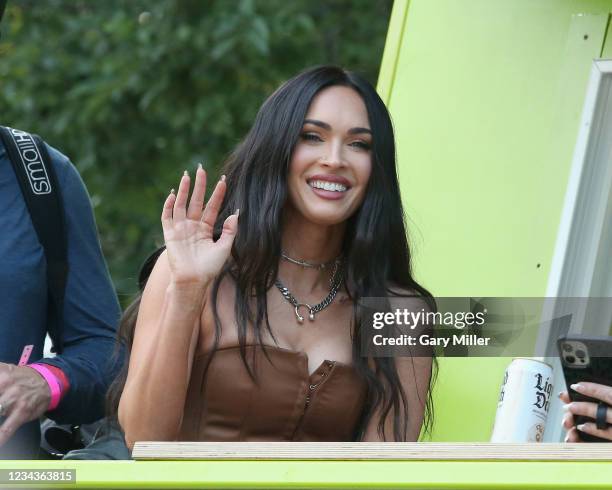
[179,345,367,441]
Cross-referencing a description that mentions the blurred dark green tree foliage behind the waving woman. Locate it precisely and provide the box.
[0,0,392,303]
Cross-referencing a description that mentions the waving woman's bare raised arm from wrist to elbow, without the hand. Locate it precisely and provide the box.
[118,251,208,449]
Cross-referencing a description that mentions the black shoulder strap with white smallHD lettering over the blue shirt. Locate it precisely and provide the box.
[0,126,68,354]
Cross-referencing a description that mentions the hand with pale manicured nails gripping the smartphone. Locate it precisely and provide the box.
[559,381,612,442]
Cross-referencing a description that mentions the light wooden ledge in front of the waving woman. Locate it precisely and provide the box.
[132,442,612,461]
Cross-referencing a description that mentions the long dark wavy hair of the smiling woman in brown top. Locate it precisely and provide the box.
[110,66,437,441]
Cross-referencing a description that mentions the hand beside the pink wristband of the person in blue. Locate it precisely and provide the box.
[0,362,51,447]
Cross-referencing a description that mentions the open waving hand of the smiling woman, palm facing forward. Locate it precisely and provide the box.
[161,165,238,286]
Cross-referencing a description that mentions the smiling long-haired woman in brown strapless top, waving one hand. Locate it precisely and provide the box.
[118,66,436,447]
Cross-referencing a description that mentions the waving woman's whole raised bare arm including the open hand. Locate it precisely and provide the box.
[118,167,238,448]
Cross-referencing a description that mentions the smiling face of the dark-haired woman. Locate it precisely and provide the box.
[288,86,372,225]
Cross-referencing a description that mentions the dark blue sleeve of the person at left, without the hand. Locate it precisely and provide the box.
[35,147,120,424]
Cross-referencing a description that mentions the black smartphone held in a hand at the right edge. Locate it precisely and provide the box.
[557,334,612,442]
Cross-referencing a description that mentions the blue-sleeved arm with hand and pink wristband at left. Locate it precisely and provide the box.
[0,142,120,447]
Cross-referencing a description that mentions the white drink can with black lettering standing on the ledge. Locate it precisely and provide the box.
[491,358,553,442]
